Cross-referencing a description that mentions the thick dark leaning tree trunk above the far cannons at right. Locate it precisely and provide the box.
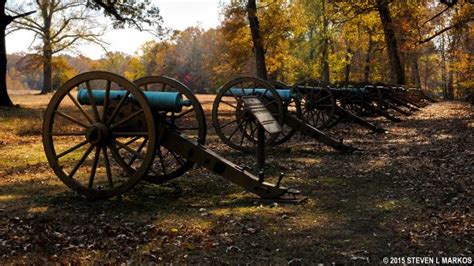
[376,0,406,85]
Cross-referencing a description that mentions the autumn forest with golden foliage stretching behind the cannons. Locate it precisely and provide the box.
[3,0,474,99]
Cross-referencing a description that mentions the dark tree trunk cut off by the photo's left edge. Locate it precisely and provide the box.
[0,0,13,106]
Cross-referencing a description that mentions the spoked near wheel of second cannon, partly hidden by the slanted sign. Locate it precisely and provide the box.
[212,77,285,152]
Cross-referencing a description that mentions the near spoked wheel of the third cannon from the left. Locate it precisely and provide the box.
[291,79,336,129]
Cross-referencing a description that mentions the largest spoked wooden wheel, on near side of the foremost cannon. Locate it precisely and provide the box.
[43,71,158,199]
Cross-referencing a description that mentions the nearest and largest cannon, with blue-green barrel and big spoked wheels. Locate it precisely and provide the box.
[43,71,299,199]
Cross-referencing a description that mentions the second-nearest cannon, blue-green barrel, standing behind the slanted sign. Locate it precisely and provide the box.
[212,77,355,152]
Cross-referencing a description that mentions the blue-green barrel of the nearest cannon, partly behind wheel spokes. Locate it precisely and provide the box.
[77,89,191,112]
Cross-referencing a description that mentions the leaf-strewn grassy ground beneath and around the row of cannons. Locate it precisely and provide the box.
[0,93,474,264]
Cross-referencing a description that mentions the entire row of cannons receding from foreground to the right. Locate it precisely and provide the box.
[43,71,431,200]
